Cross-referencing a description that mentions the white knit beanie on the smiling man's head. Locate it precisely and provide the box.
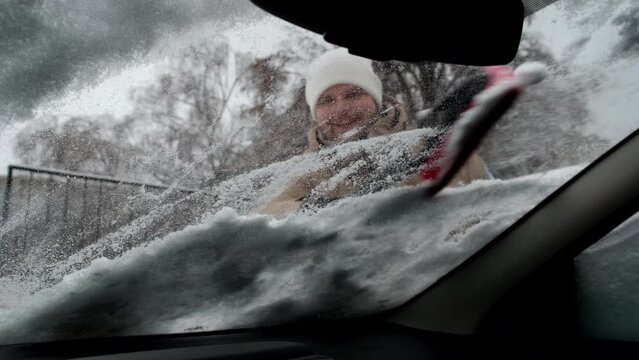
[305,48,382,118]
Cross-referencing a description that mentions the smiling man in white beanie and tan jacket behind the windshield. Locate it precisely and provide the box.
[258,48,488,217]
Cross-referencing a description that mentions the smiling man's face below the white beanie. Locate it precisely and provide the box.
[315,84,377,140]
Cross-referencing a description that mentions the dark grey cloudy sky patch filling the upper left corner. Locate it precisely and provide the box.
[0,0,263,122]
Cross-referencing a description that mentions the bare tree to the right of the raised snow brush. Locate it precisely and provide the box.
[481,33,607,178]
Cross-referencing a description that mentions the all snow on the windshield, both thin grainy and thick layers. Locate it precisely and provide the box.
[0,116,580,342]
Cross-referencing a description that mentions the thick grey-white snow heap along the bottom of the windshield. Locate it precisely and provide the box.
[0,162,580,343]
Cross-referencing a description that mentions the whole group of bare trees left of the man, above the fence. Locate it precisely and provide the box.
[13,37,314,188]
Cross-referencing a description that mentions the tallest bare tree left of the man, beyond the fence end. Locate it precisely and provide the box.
[131,40,250,187]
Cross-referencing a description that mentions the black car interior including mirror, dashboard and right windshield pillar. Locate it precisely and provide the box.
[0,0,639,360]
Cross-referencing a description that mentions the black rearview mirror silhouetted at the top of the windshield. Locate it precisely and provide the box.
[251,0,524,65]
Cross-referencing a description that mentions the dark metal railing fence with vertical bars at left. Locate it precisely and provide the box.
[0,165,195,274]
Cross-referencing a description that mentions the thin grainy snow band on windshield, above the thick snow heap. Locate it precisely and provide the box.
[0,129,437,287]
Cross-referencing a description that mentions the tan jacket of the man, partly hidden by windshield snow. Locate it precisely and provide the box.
[257,100,489,218]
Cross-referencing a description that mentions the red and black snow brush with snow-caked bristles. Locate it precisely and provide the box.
[416,62,546,198]
